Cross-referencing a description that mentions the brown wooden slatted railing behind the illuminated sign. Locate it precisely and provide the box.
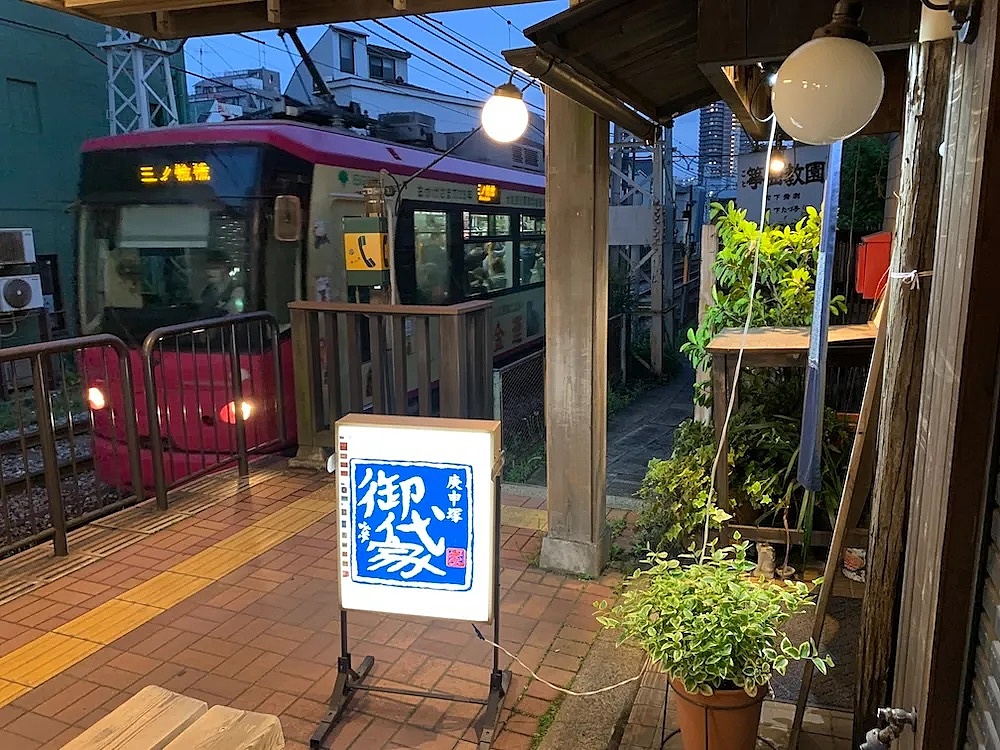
[289,301,493,455]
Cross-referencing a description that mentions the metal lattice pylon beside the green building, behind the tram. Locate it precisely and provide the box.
[99,26,181,135]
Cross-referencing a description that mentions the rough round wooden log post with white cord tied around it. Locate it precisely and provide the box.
[854,40,952,745]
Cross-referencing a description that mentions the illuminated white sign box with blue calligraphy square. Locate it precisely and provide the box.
[328,414,499,622]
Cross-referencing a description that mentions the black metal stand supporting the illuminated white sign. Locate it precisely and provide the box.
[309,472,511,750]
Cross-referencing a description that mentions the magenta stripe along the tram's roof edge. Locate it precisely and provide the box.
[82,120,545,193]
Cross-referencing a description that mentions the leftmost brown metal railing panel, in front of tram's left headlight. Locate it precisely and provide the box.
[0,335,142,558]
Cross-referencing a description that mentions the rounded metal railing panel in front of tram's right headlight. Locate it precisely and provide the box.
[142,312,287,510]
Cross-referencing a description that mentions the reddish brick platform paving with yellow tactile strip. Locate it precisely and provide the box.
[0,466,617,750]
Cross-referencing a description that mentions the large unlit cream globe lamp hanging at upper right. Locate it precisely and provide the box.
[771,0,885,146]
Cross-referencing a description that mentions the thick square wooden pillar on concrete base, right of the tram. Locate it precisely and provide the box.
[541,67,610,576]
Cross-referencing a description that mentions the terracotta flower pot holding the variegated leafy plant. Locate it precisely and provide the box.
[670,680,766,750]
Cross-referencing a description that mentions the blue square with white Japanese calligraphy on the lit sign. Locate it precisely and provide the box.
[344,460,473,591]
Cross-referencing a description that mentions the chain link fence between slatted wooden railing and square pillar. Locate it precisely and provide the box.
[493,349,545,484]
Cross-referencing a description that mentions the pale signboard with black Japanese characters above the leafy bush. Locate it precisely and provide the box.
[736,146,830,225]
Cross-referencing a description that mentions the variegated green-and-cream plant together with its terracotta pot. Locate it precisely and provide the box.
[597,541,833,750]
